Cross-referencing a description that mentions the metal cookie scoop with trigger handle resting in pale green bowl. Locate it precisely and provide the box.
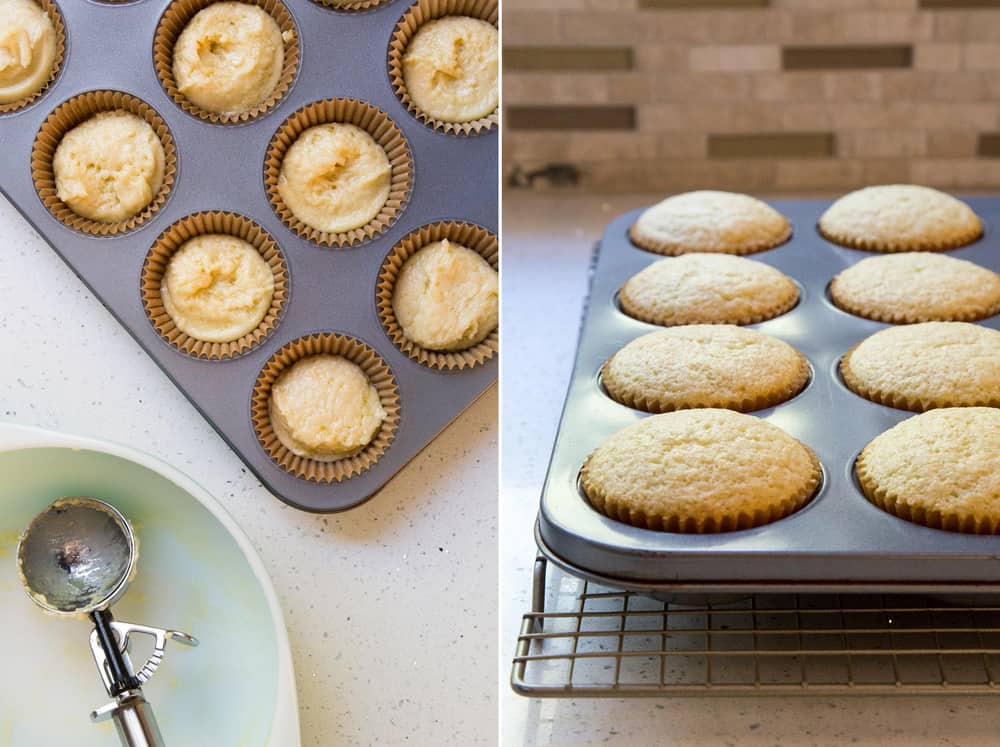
[17,497,198,747]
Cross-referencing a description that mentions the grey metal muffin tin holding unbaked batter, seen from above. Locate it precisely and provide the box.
[0,0,498,511]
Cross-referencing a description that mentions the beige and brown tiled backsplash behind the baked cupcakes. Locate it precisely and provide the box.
[504,0,1000,191]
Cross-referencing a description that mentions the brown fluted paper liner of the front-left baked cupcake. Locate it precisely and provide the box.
[578,444,823,534]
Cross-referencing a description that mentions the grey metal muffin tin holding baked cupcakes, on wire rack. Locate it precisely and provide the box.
[536,198,1000,593]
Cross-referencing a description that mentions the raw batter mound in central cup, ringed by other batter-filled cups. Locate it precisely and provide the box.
[277,122,392,233]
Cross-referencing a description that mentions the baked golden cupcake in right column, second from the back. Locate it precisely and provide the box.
[830,252,1000,324]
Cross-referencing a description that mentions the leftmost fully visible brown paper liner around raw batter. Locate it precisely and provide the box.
[31,90,177,236]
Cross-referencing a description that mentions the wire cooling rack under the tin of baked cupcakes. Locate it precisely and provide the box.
[511,557,1000,697]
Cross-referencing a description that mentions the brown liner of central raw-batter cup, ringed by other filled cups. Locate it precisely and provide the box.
[264,99,413,247]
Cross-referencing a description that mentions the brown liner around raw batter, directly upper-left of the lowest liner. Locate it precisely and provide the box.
[140,211,290,360]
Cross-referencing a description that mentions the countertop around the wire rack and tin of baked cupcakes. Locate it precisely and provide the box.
[500,192,1000,747]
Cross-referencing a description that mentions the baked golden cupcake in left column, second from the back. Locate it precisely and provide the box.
[618,254,799,327]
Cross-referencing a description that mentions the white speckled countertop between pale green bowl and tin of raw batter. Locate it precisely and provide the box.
[0,198,498,747]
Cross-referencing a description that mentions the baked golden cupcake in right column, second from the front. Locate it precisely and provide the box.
[840,322,1000,412]
